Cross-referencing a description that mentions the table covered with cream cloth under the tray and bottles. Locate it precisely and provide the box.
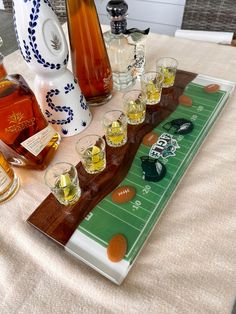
[0,26,236,314]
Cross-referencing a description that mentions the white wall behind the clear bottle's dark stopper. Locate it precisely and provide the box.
[95,0,186,36]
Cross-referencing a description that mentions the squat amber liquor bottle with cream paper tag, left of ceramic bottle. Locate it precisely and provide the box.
[0,54,60,169]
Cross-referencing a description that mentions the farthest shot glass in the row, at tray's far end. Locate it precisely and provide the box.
[156,57,178,88]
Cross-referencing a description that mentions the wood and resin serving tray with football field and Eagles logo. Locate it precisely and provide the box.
[28,71,234,284]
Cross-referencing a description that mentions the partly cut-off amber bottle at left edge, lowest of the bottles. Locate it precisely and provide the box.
[0,151,19,203]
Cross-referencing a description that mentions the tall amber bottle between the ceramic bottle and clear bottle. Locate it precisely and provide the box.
[66,0,113,105]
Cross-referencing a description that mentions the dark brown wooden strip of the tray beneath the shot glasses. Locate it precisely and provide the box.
[27,70,196,246]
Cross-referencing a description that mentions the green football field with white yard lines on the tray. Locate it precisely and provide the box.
[78,82,229,263]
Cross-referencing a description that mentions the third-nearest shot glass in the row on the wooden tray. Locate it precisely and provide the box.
[103,110,127,147]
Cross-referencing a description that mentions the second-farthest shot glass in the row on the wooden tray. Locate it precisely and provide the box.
[141,71,163,105]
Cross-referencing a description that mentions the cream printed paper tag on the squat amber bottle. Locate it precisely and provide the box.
[21,125,56,156]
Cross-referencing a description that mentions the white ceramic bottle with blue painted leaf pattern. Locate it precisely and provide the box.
[13,0,92,136]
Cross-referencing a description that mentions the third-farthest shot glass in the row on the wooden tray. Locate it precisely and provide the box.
[123,89,147,125]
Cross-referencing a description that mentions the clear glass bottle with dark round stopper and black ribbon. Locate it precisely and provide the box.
[103,0,149,90]
